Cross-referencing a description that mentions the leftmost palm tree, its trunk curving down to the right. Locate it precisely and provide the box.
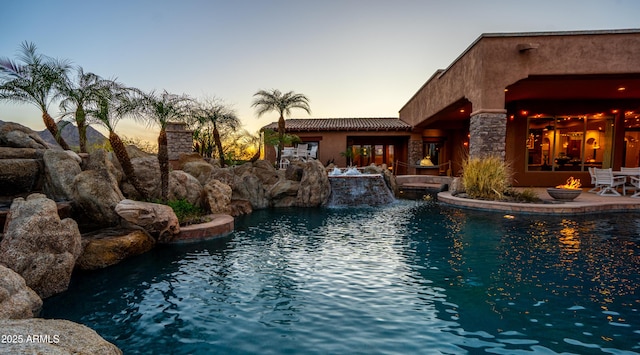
[0,42,70,150]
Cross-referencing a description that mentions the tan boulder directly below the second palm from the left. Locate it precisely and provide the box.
[42,149,82,201]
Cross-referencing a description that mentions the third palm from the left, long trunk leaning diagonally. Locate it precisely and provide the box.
[87,81,148,199]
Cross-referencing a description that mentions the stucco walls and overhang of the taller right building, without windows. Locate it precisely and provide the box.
[400,29,640,186]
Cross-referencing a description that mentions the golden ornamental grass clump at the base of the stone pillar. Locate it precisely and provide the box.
[462,156,512,200]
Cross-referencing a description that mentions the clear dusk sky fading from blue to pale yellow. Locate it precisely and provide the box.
[0,0,640,142]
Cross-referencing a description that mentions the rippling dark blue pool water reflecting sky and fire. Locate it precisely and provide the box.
[43,201,640,354]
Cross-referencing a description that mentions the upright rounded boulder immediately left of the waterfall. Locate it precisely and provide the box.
[297,160,331,207]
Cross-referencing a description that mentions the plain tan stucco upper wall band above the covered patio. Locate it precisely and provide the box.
[400,30,640,126]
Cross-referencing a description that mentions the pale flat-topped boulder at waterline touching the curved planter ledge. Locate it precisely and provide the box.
[115,200,180,243]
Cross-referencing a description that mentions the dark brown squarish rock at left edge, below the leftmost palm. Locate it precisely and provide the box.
[0,159,44,196]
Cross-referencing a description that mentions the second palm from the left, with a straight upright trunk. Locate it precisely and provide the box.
[58,67,109,153]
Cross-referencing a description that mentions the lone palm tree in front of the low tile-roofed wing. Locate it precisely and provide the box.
[251,89,311,166]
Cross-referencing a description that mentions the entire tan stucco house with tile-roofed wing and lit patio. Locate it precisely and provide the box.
[265,29,640,186]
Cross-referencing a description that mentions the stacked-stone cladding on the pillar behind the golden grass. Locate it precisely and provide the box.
[469,109,507,159]
